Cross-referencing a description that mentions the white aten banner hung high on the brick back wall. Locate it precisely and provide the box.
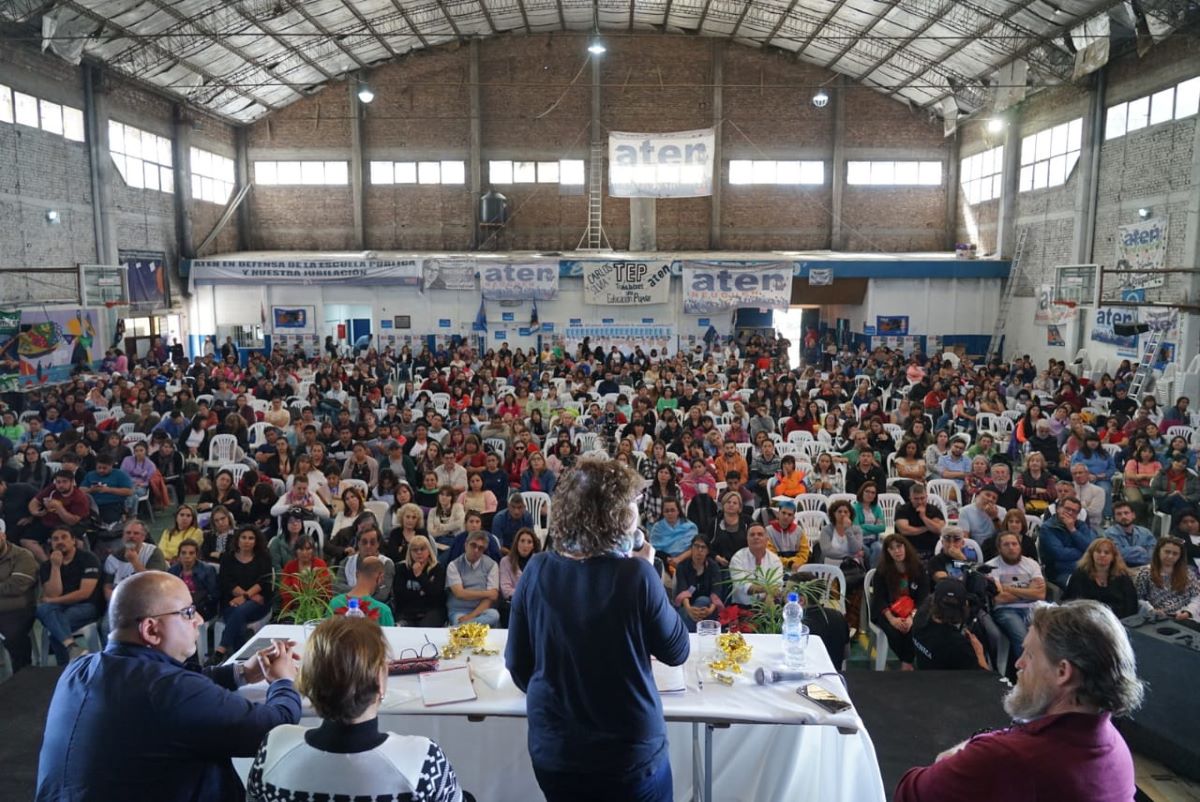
[608,128,714,198]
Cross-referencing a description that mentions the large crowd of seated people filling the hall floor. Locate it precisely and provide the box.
[0,326,1200,668]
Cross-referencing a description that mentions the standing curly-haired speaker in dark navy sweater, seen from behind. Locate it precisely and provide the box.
[505,459,689,802]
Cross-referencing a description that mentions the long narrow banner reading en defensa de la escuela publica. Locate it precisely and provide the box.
[188,258,421,287]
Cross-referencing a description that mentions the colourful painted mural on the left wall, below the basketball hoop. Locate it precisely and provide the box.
[17,310,101,385]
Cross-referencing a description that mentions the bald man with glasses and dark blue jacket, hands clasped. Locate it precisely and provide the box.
[36,571,300,802]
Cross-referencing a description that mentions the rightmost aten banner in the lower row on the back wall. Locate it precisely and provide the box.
[683,262,792,315]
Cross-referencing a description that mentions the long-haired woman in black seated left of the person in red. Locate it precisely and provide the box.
[210,526,274,665]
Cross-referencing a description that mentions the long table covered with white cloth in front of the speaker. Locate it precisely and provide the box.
[234,624,886,802]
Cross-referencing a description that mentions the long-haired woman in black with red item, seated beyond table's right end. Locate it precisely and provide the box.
[871,534,929,671]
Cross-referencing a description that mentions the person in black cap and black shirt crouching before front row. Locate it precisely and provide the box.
[912,579,988,671]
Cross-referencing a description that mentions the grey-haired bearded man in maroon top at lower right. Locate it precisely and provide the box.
[894,602,1144,802]
